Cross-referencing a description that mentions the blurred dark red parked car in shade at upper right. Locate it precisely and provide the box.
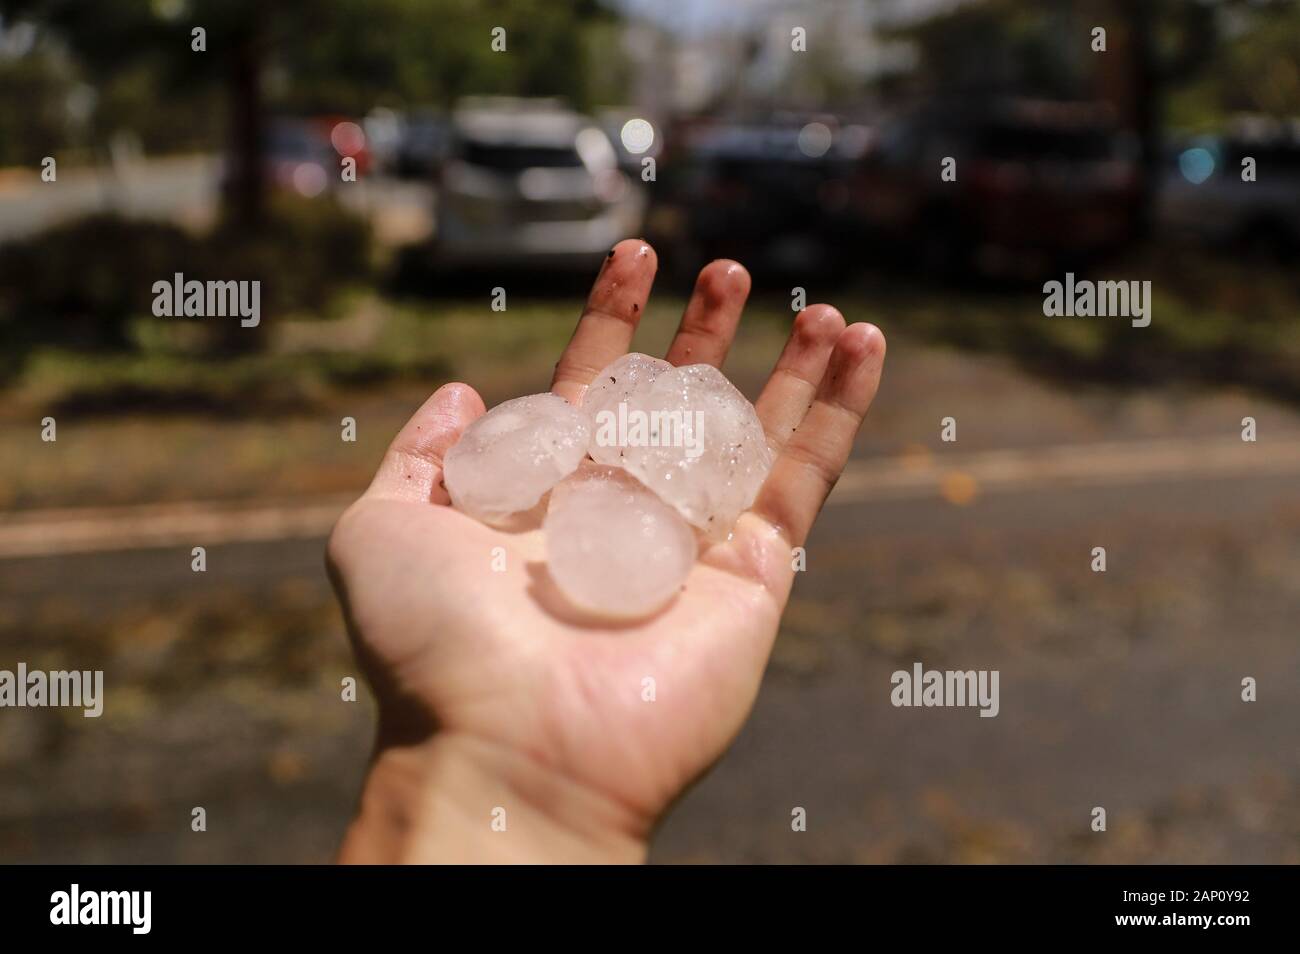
[853,100,1140,272]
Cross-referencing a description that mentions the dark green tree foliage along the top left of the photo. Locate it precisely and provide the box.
[0,0,625,155]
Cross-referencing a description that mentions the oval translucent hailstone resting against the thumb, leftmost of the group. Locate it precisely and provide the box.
[442,394,590,524]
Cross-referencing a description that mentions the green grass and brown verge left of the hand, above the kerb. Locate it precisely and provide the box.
[0,296,784,509]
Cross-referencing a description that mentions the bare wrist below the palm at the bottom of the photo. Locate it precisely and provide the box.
[339,733,649,864]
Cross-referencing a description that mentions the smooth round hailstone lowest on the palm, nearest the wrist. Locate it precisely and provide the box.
[542,464,696,617]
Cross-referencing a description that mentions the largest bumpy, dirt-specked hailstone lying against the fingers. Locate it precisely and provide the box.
[584,355,774,539]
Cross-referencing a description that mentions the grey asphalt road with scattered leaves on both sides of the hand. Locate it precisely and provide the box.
[0,438,1300,862]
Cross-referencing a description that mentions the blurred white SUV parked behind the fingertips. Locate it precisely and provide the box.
[436,99,645,268]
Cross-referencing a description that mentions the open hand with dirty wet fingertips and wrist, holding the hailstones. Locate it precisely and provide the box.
[328,239,885,862]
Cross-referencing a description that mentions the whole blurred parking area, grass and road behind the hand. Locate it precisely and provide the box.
[0,0,1300,863]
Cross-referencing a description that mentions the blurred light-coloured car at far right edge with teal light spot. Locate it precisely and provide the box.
[1157,123,1300,259]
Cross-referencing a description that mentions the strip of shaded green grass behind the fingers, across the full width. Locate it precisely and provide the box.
[8,240,1300,416]
